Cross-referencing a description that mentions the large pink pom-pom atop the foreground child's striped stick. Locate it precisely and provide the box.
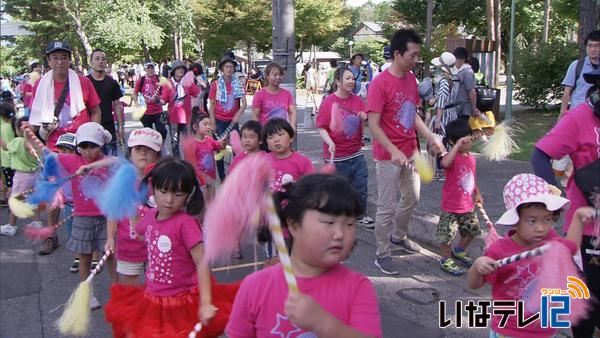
[204,154,272,263]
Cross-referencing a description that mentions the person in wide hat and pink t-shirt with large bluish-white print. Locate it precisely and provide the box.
[208,55,246,180]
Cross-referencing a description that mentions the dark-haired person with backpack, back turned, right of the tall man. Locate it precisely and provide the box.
[452,47,481,120]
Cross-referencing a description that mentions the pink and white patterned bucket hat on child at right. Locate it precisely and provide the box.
[496,174,569,225]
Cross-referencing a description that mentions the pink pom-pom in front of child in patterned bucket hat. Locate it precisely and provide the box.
[526,241,591,324]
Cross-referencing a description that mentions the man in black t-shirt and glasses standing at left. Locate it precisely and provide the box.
[88,49,125,155]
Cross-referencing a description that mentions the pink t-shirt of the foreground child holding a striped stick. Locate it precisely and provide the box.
[225,264,382,338]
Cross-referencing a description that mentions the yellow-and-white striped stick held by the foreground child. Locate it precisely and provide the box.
[264,191,298,293]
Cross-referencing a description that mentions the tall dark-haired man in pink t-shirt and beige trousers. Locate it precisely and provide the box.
[367,29,443,275]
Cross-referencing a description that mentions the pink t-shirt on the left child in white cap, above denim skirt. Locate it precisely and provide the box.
[58,154,109,216]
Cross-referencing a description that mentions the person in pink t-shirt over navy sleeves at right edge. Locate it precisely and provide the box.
[531,68,600,338]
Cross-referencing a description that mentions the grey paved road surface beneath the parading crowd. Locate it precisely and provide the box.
[0,93,560,338]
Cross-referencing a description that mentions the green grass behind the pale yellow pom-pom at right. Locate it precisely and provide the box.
[473,109,558,161]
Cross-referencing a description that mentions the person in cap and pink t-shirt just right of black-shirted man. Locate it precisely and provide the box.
[133,60,167,140]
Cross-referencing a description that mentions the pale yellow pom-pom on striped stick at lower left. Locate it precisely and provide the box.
[57,250,111,336]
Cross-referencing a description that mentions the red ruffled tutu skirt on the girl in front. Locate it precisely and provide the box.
[104,278,241,338]
